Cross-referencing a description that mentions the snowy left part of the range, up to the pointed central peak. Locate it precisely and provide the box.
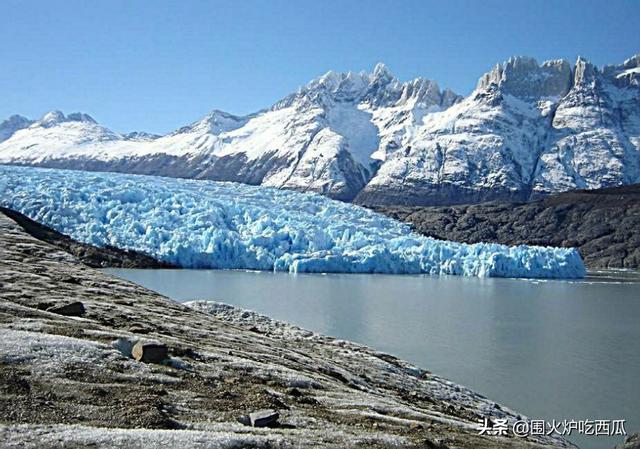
[0,64,460,200]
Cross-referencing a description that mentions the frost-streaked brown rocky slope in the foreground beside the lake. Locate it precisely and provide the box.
[0,214,566,449]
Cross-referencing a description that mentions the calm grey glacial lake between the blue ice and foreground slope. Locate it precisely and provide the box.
[104,269,640,449]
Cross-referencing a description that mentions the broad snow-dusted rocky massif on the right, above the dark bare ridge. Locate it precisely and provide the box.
[357,56,640,205]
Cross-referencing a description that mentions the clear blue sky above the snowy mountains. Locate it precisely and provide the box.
[0,0,640,133]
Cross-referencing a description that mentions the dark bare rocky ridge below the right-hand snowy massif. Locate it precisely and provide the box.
[373,184,640,269]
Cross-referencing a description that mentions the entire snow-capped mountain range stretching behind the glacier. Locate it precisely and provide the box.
[0,56,640,204]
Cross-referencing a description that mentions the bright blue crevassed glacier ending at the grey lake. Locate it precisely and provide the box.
[0,165,585,278]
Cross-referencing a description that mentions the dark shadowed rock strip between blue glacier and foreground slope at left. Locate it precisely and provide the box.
[0,207,171,268]
